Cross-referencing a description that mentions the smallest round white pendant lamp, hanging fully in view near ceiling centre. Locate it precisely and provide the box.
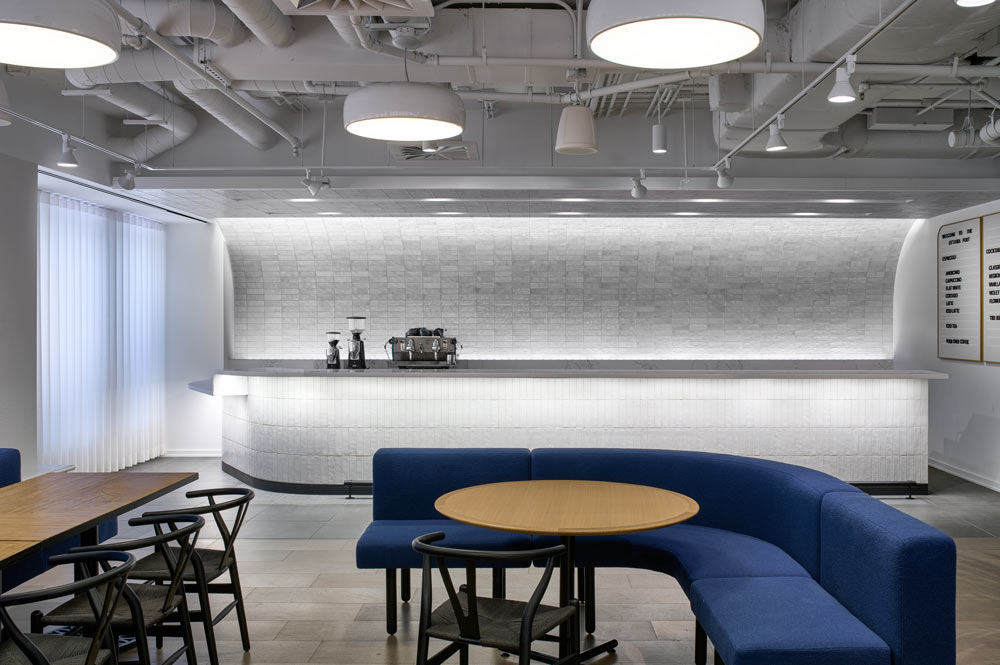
[344,83,465,143]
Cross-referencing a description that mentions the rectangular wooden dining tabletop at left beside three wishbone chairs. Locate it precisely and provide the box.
[0,473,198,579]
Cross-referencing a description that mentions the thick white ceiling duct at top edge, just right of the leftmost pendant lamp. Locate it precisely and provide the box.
[121,0,250,47]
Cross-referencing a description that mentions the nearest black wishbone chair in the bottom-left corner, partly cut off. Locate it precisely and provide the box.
[0,551,135,665]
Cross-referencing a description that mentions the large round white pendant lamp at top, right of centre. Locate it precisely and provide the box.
[587,0,764,69]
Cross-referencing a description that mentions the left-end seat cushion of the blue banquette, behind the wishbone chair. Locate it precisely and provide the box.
[355,519,531,568]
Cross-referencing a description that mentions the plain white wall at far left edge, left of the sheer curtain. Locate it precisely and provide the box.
[0,150,38,474]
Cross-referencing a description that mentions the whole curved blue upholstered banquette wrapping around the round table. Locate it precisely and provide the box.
[357,448,956,665]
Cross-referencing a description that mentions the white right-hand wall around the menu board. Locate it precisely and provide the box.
[895,201,1000,490]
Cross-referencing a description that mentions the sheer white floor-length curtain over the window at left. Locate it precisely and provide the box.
[38,192,166,471]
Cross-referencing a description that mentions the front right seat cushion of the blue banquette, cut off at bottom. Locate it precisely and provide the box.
[691,577,892,665]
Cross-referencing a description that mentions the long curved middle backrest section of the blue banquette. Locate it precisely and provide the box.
[531,448,861,579]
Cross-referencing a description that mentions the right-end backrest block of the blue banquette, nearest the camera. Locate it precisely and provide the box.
[819,492,955,665]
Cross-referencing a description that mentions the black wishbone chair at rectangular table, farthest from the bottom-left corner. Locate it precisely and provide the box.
[132,487,254,665]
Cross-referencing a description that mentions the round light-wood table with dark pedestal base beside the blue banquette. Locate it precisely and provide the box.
[434,480,698,662]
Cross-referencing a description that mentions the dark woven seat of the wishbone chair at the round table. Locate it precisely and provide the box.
[427,591,576,652]
